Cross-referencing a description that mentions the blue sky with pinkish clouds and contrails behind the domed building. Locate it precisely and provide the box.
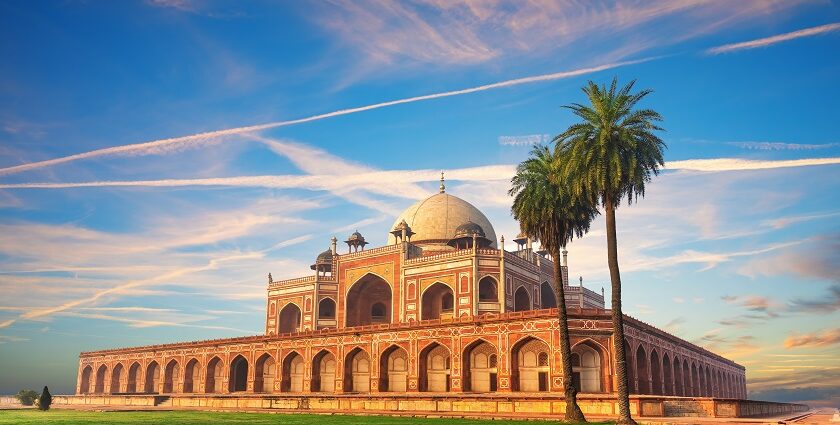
[0,0,840,405]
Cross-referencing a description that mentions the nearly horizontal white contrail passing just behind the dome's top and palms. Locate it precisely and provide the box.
[0,157,840,190]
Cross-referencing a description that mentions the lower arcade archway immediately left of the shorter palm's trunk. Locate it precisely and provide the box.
[510,337,551,392]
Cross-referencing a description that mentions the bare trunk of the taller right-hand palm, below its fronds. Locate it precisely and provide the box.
[604,197,636,425]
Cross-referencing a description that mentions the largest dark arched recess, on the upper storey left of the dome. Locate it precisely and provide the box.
[345,273,391,327]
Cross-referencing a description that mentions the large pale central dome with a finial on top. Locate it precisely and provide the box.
[388,173,496,249]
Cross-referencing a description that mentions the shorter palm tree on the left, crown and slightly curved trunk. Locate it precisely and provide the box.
[508,146,598,422]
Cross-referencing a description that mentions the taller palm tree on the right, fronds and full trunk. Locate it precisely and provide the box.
[554,78,666,424]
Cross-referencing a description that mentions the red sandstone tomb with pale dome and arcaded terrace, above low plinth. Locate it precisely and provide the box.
[76,188,746,404]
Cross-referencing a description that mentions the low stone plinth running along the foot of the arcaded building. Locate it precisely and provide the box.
[53,393,808,418]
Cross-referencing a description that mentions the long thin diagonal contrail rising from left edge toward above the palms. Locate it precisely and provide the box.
[0,57,657,175]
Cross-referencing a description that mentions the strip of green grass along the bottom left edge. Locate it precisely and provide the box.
[0,409,612,425]
